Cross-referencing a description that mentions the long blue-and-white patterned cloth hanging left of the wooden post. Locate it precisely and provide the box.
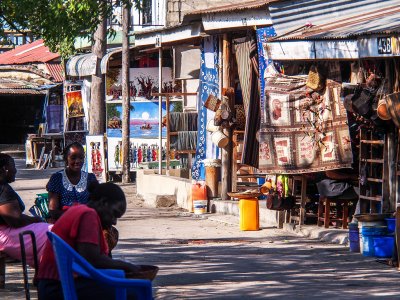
[192,36,219,180]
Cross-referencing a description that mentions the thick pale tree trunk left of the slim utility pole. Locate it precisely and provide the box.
[89,15,107,135]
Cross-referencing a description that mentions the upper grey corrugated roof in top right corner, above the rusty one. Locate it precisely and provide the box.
[268,0,399,36]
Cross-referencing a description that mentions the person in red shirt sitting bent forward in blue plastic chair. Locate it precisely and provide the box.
[38,183,155,300]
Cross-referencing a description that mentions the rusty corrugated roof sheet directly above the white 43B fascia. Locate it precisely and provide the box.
[274,6,400,40]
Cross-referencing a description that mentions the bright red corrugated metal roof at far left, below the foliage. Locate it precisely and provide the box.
[0,40,60,65]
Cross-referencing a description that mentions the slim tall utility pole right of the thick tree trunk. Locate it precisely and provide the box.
[121,0,131,183]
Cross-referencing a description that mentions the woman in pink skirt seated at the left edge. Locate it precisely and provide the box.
[0,153,52,266]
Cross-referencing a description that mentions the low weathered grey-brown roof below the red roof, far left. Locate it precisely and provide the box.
[0,78,46,95]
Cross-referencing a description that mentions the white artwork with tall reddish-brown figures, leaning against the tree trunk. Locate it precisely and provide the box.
[86,135,106,182]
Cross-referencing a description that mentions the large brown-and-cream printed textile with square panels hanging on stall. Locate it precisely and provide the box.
[259,69,353,174]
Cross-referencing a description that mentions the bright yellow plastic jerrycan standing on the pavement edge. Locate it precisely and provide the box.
[239,198,260,231]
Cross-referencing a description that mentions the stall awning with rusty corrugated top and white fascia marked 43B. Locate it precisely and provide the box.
[268,1,400,60]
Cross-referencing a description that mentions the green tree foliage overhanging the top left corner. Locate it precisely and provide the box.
[0,0,140,58]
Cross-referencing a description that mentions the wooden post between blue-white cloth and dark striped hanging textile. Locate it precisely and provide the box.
[221,33,233,200]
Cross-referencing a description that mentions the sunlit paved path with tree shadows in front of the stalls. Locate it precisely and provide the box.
[0,163,400,299]
